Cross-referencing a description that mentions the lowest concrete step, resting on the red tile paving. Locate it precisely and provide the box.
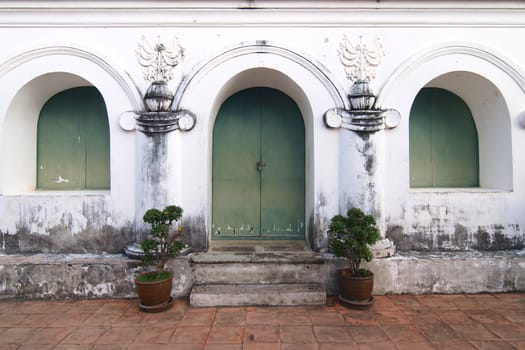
[190,284,326,307]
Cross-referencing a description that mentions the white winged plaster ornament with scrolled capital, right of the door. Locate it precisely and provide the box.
[324,36,401,132]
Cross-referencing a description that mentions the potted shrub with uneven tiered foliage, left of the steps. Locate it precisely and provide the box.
[135,205,185,312]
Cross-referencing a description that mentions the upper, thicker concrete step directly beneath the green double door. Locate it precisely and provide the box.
[192,252,325,285]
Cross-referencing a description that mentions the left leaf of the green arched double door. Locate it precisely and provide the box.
[213,90,260,237]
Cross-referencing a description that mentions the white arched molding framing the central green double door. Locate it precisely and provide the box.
[174,42,347,248]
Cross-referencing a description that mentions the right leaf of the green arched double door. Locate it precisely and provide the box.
[261,90,304,238]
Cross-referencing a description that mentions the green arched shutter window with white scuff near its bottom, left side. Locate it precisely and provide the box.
[37,87,110,190]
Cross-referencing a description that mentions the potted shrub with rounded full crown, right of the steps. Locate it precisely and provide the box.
[328,208,380,309]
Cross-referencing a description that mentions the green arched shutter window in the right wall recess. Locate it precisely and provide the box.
[409,88,479,187]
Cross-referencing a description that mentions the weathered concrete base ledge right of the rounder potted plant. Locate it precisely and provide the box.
[369,250,525,294]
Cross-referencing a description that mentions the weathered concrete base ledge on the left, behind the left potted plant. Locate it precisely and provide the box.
[0,254,192,299]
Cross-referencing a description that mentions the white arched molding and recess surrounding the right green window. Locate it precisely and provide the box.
[378,43,525,205]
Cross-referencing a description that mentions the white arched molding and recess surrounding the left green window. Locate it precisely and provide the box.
[0,44,141,213]
